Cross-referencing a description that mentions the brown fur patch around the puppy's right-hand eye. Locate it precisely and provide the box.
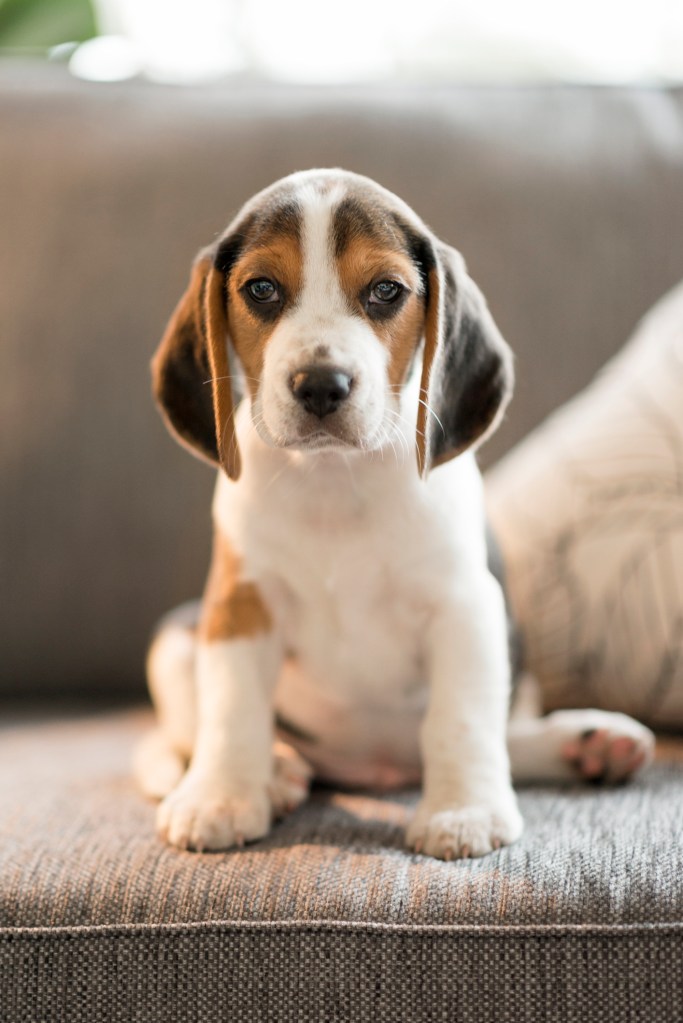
[337,235,424,391]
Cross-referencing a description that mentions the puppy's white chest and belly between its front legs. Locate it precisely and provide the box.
[215,439,483,784]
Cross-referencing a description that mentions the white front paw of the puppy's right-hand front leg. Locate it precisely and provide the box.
[406,801,523,859]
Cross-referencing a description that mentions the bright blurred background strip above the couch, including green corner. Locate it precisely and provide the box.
[0,0,683,84]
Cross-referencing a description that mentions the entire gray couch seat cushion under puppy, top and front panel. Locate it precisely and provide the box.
[0,712,683,1023]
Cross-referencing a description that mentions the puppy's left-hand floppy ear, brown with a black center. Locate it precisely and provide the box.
[151,252,240,480]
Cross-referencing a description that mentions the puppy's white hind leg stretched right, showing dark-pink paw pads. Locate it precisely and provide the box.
[507,675,654,784]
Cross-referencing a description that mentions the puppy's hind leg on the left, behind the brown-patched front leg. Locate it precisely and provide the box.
[133,602,198,799]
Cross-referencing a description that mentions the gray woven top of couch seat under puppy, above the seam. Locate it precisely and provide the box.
[0,711,683,927]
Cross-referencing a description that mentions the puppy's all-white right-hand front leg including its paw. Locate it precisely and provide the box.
[407,571,522,859]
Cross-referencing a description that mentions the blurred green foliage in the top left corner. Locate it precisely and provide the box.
[0,0,97,50]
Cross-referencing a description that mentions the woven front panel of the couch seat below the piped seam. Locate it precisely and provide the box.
[0,924,683,1023]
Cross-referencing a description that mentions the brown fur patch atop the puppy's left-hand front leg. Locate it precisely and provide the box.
[198,533,273,642]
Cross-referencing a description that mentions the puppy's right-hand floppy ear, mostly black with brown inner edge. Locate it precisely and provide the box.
[417,240,513,476]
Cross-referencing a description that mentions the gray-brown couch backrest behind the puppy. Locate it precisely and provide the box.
[0,64,683,694]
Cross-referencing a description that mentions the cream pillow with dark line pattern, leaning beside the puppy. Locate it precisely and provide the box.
[487,284,683,728]
